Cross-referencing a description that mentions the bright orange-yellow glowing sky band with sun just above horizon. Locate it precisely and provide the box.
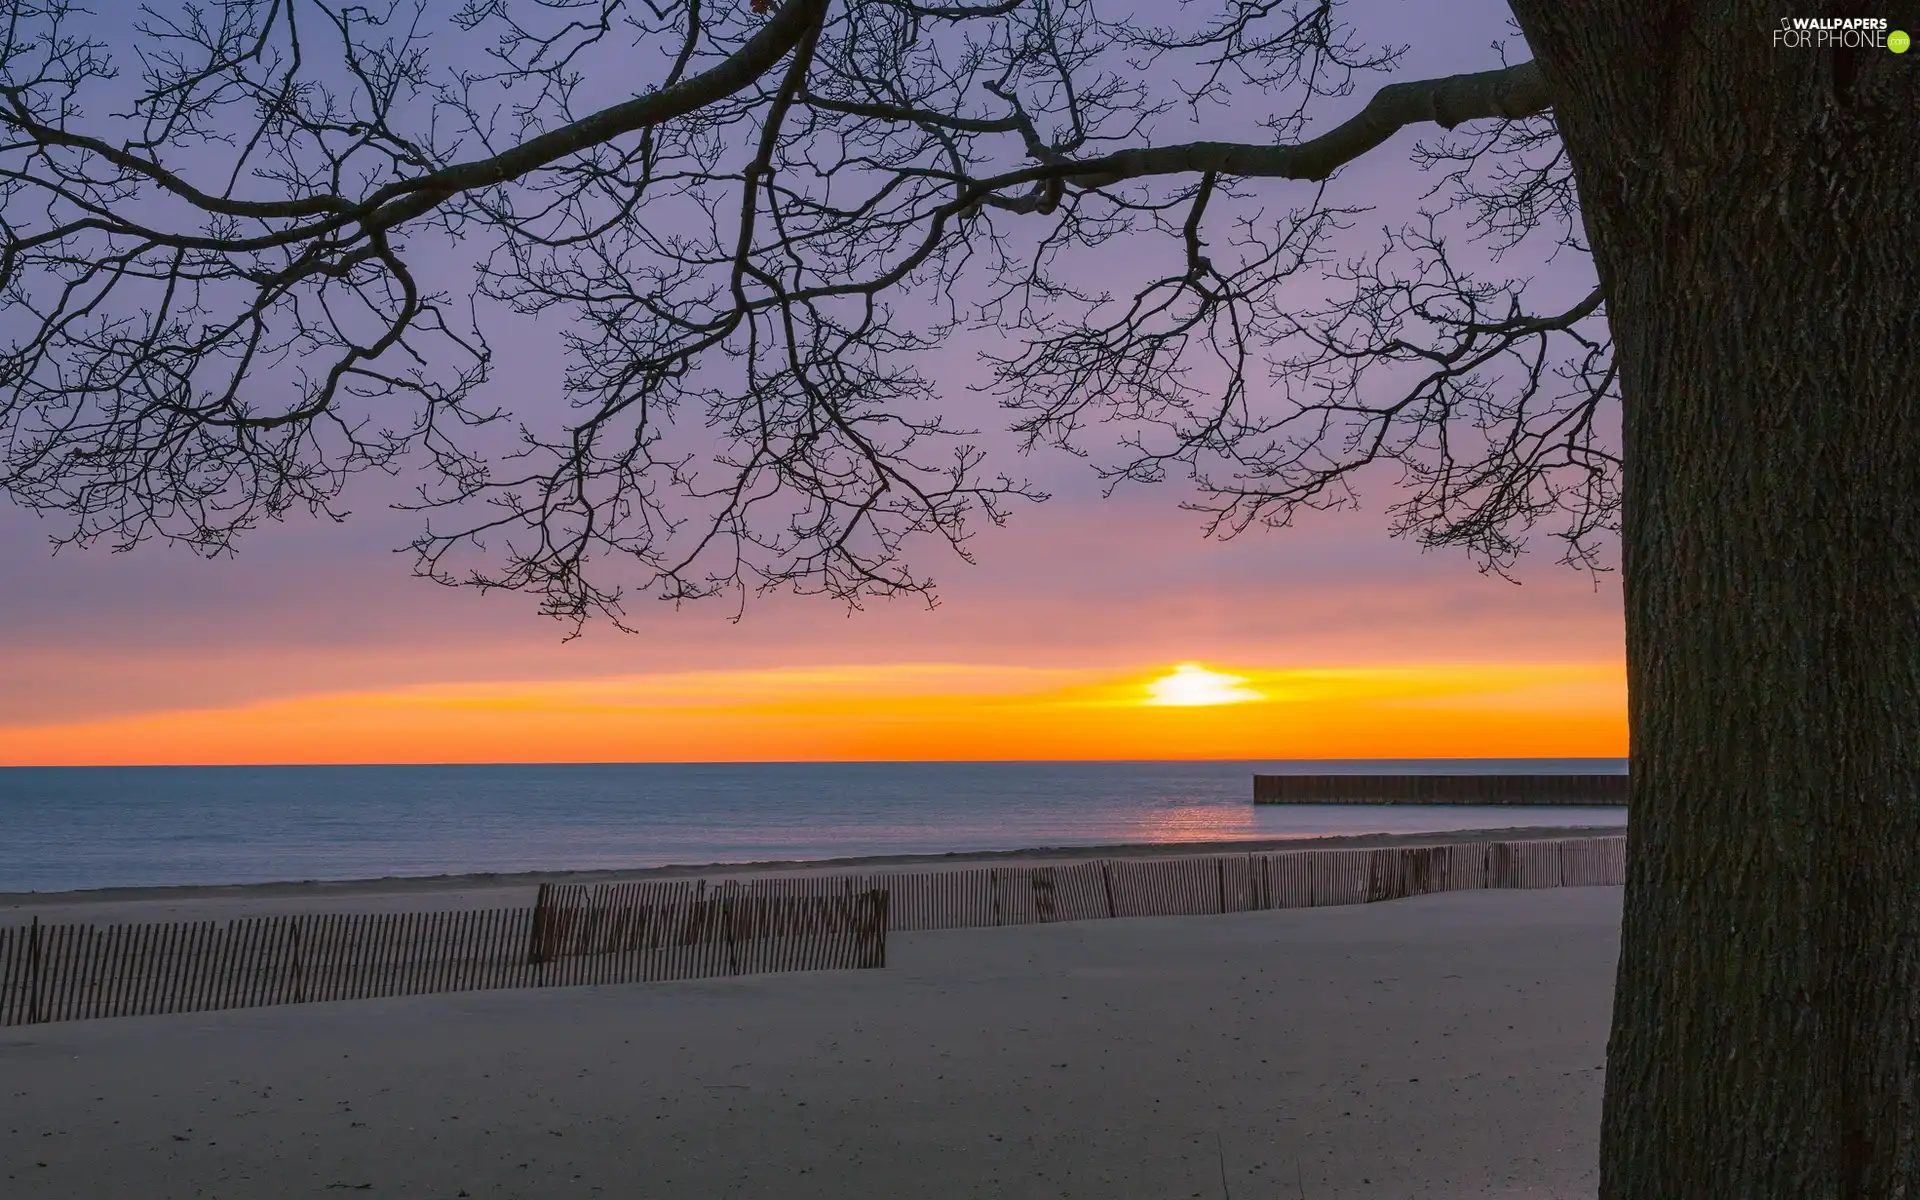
[0,662,1626,766]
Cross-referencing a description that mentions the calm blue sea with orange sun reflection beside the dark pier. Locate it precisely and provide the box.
[0,758,1626,891]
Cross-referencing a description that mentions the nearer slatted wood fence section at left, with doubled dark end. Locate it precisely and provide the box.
[0,889,887,1025]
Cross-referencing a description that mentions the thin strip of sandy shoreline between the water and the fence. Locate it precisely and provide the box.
[0,826,1626,910]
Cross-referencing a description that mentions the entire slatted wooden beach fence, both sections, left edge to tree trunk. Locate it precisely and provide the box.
[0,837,1626,1025]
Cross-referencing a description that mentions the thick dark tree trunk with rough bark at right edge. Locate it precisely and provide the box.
[1513,0,1920,1200]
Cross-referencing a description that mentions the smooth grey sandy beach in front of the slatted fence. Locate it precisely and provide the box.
[0,860,1620,1200]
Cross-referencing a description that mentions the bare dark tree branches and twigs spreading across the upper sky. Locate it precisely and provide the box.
[0,0,1617,628]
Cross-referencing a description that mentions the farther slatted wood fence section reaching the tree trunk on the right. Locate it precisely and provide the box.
[541,837,1626,933]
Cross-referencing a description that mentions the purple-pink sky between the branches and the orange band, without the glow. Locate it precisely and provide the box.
[0,0,1620,752]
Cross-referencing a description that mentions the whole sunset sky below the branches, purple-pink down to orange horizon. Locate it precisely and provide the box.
[0,0,1626,764]
